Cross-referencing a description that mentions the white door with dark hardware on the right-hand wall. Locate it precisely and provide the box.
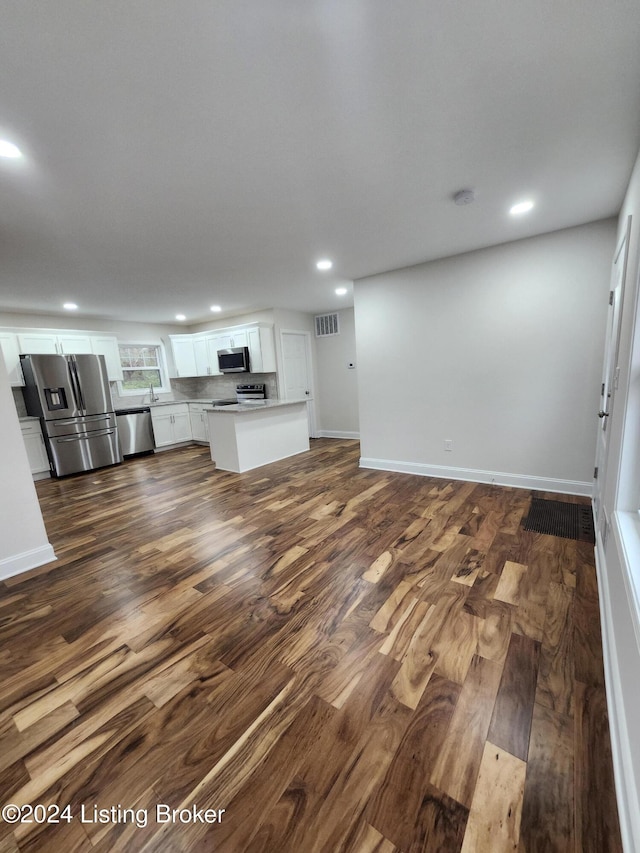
[593,217,631,534]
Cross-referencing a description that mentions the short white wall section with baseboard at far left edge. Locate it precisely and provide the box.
[0,352,55,579]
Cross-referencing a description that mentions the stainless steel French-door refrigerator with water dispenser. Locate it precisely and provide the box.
[20,355,122,477]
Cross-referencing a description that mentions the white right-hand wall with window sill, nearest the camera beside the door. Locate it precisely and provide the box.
[596,143,640,851]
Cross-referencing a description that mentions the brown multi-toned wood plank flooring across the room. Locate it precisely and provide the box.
[0,439,621,853]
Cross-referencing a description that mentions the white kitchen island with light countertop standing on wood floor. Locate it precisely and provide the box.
[207,400,309,474]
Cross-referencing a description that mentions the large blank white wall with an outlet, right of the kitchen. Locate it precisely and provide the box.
[355,220,616,494]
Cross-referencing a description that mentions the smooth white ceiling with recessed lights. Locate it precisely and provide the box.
[0,0,640,323]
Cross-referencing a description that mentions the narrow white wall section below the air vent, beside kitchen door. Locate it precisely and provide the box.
[316,308,360,438]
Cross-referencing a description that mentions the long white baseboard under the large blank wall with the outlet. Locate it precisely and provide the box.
[360,456,593,498]
